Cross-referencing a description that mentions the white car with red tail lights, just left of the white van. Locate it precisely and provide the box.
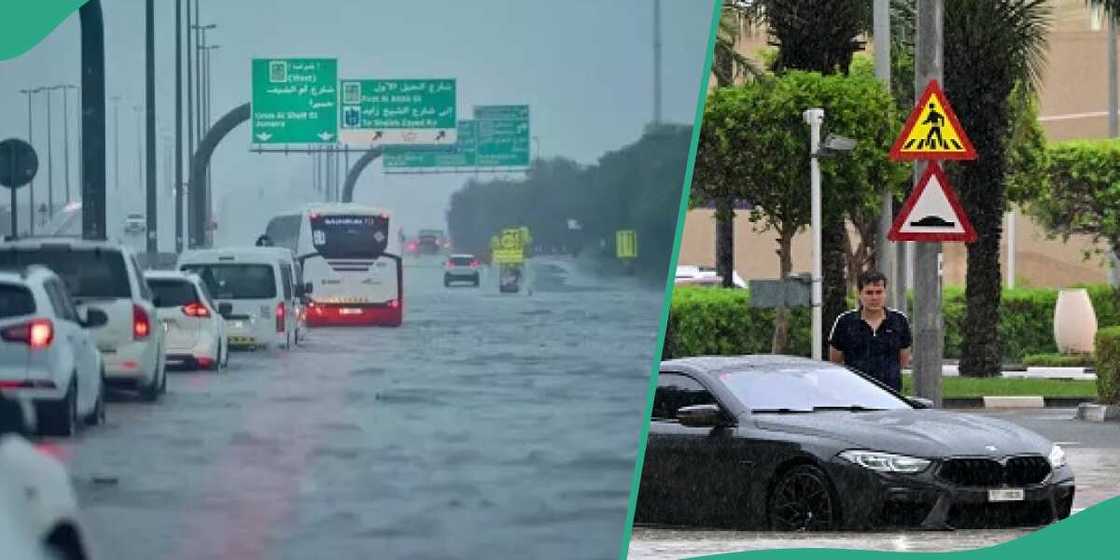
[144,271,230,372]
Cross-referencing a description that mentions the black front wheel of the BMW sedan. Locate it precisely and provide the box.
[766,465,840,532]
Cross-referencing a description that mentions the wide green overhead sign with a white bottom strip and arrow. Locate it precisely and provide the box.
[339,80,457,146]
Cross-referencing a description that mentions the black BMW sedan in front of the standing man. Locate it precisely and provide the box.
[636,355,1074,531]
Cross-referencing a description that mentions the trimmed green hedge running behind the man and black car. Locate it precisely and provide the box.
[665,286,1120,363]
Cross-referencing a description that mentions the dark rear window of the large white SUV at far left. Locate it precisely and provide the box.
[0,246,132,299]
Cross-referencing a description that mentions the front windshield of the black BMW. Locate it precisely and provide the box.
[719,365,913,412]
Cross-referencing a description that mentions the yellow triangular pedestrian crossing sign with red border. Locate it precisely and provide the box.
[890,80,977,161]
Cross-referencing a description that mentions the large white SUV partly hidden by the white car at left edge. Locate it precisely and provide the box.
[0,237,167,401]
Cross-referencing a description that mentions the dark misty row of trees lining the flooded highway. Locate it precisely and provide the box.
[447,124,692,277]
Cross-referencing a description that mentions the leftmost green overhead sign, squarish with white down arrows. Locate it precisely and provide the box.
[252,58,338,143]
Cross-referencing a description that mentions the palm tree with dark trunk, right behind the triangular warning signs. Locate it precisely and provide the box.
[944,0,1052,376]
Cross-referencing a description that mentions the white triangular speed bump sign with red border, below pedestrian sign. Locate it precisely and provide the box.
[887,161,977,243]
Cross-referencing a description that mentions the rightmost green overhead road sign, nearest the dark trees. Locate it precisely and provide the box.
[475,105,530,167]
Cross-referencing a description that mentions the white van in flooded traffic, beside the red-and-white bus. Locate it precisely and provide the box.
[176,246,304,349]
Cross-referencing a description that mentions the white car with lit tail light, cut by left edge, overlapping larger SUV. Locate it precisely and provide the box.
[0,265,108,436]
